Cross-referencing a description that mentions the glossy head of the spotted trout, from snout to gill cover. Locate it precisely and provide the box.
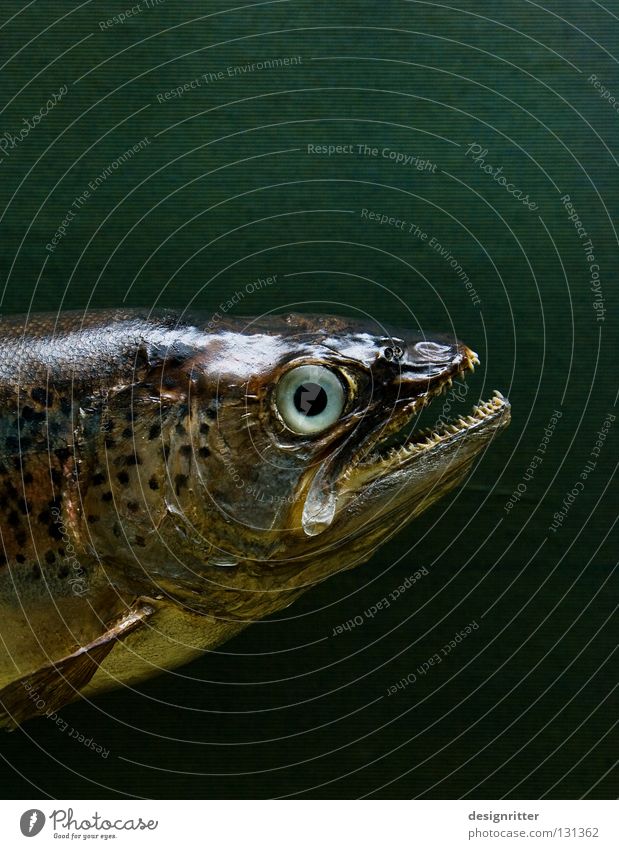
[115,314,510,618]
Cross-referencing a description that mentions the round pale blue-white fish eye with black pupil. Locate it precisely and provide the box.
[275,365,345,434]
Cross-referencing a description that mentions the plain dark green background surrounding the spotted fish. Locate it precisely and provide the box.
[0,0,619,799]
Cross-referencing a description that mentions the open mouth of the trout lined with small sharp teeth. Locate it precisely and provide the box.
[354,349,510,477]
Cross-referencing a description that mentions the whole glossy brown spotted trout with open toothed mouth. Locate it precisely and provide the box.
[0,309,510,730]
